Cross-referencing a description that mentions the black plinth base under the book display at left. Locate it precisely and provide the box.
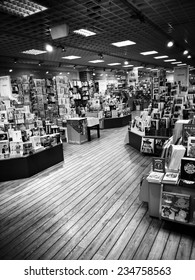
[0,143,64,182]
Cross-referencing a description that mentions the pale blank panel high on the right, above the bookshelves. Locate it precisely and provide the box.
[174,65,189,87]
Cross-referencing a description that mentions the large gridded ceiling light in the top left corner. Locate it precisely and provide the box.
[0,0,47,17]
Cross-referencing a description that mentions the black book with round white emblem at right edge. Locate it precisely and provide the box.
[180,157,195,181]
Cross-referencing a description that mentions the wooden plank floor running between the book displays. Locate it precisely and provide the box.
[0,127,195,260]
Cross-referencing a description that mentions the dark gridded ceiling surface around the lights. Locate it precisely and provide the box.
[0,0,195,72]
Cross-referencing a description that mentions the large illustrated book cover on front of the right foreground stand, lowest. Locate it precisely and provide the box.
[161,191,190,223]
